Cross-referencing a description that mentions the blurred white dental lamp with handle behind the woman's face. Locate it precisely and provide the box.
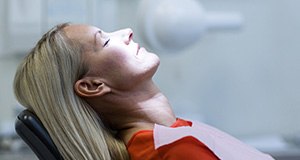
[137,0,243,52]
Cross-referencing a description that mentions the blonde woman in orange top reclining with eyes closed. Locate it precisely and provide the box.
[14,24,270,160]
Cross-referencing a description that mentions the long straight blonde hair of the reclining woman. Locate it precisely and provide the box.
[14,23,129,160]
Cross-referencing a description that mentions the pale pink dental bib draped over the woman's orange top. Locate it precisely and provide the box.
[153,122,274,160]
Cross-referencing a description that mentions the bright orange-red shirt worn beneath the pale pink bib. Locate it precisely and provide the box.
[127,119,219,160]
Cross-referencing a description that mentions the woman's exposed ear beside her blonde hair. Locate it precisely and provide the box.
[74,77,111,98]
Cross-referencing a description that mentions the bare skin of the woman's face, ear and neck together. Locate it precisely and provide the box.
[64,25,176,143]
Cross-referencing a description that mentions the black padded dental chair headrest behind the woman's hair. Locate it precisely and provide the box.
[15,110,63,160]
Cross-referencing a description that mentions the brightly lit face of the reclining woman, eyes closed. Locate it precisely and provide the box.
[65,25,159,89]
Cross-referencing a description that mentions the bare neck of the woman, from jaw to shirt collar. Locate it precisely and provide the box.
[93,80,176,143]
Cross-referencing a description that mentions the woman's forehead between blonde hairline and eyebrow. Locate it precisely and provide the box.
[64,24,99,43]
